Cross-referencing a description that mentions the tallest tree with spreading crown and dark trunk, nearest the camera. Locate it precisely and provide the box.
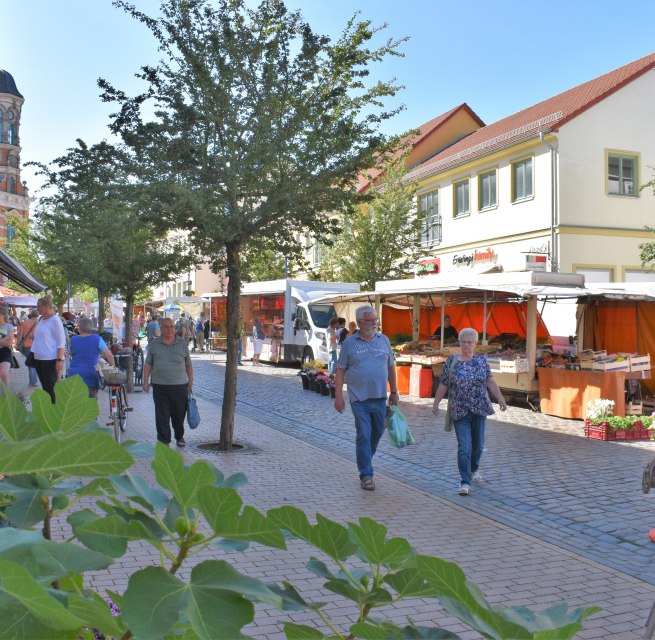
[100,0,408,449]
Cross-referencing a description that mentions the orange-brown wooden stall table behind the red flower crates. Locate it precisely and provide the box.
[538,367,650,420]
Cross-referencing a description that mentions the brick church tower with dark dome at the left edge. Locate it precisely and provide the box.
[0,69,33,249]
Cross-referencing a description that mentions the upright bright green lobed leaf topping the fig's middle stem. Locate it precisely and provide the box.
[152,443,215,507]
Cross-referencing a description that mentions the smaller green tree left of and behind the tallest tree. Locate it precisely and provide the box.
[32,140,194,388]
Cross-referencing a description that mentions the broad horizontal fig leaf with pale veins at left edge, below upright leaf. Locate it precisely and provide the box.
[0,432,134,477]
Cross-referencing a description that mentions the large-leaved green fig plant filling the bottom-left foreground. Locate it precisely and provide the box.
[0,377,598,640]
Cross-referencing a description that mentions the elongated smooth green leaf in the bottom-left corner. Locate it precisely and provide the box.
[0,559,83,629]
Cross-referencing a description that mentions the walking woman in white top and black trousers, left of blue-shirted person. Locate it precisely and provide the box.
[32,295,66,404]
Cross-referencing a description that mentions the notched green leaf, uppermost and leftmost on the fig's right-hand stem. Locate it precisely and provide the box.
[268,505,357,560]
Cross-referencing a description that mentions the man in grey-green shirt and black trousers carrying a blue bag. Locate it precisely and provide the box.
[143,318,193,447]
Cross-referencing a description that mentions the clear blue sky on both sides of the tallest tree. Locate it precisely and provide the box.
[7,0,655,190]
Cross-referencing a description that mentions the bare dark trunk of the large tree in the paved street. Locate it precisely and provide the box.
[219,243,241,451]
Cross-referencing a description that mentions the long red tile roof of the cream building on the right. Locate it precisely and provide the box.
[408,53,655,179]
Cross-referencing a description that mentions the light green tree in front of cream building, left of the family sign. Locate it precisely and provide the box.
[320,154,425,290]
